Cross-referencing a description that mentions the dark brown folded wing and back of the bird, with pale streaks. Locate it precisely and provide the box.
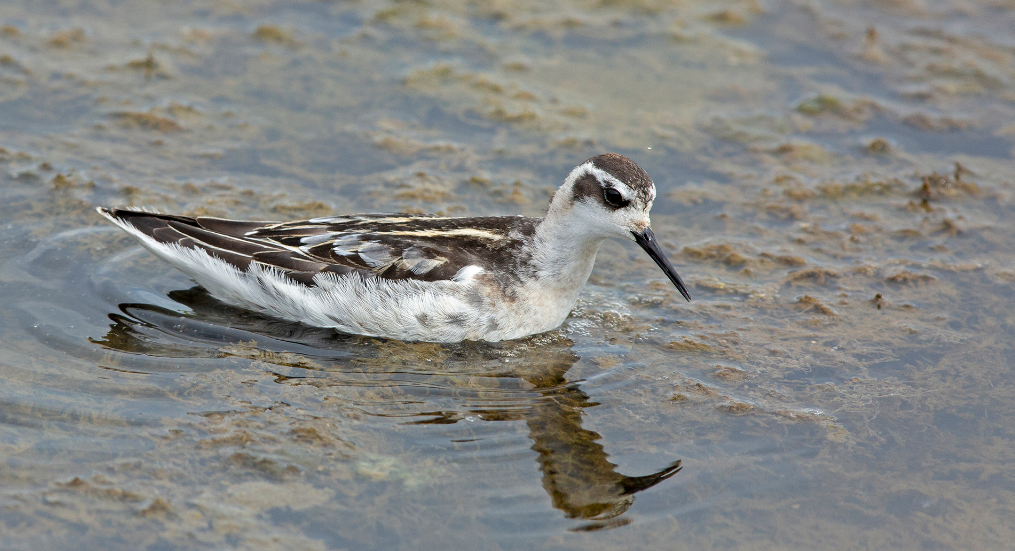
[99,209,539,284]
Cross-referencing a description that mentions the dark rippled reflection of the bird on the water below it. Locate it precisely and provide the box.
[91,287,681,531]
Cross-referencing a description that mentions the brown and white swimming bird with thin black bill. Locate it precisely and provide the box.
[97,153,690,342]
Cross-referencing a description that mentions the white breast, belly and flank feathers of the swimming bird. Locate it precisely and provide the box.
[113,218,595,342]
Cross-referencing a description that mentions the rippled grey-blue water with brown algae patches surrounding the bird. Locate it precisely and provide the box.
[0,0,1015,550]
